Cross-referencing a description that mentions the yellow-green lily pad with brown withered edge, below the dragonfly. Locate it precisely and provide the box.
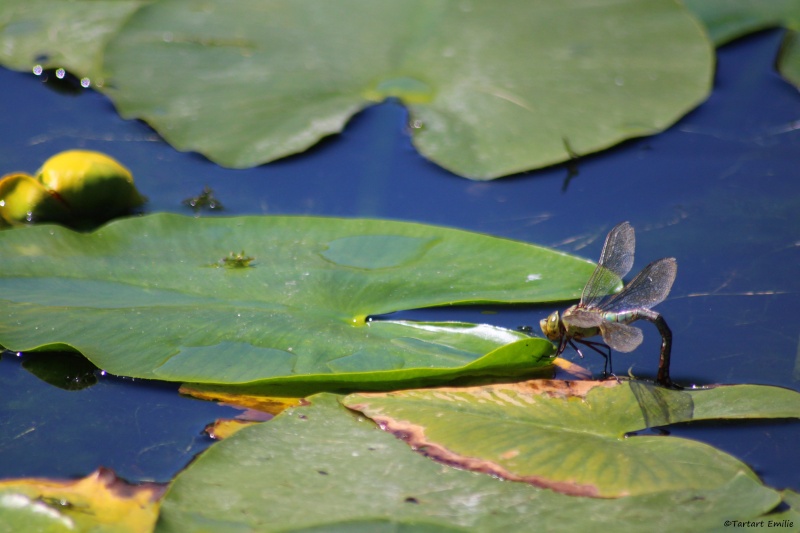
[344,380,800,498]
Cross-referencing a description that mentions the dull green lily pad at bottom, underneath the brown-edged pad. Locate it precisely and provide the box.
[156,395,780,533]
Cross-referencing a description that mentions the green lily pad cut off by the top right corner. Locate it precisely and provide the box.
[684,0,800,87]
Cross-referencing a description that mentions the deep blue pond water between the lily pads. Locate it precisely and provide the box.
[0,31,800,490]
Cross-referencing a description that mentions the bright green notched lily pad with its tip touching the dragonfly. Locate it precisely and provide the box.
[0,214,593,385]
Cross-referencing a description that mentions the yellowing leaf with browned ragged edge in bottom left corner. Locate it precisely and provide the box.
[0,468,164,533]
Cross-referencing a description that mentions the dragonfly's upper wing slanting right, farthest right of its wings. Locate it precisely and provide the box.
[601,257,678,313]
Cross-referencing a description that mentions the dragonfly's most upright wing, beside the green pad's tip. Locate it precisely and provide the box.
[581,222,636,307]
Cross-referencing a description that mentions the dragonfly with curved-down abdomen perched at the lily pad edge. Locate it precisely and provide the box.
[539,222,679,388]
